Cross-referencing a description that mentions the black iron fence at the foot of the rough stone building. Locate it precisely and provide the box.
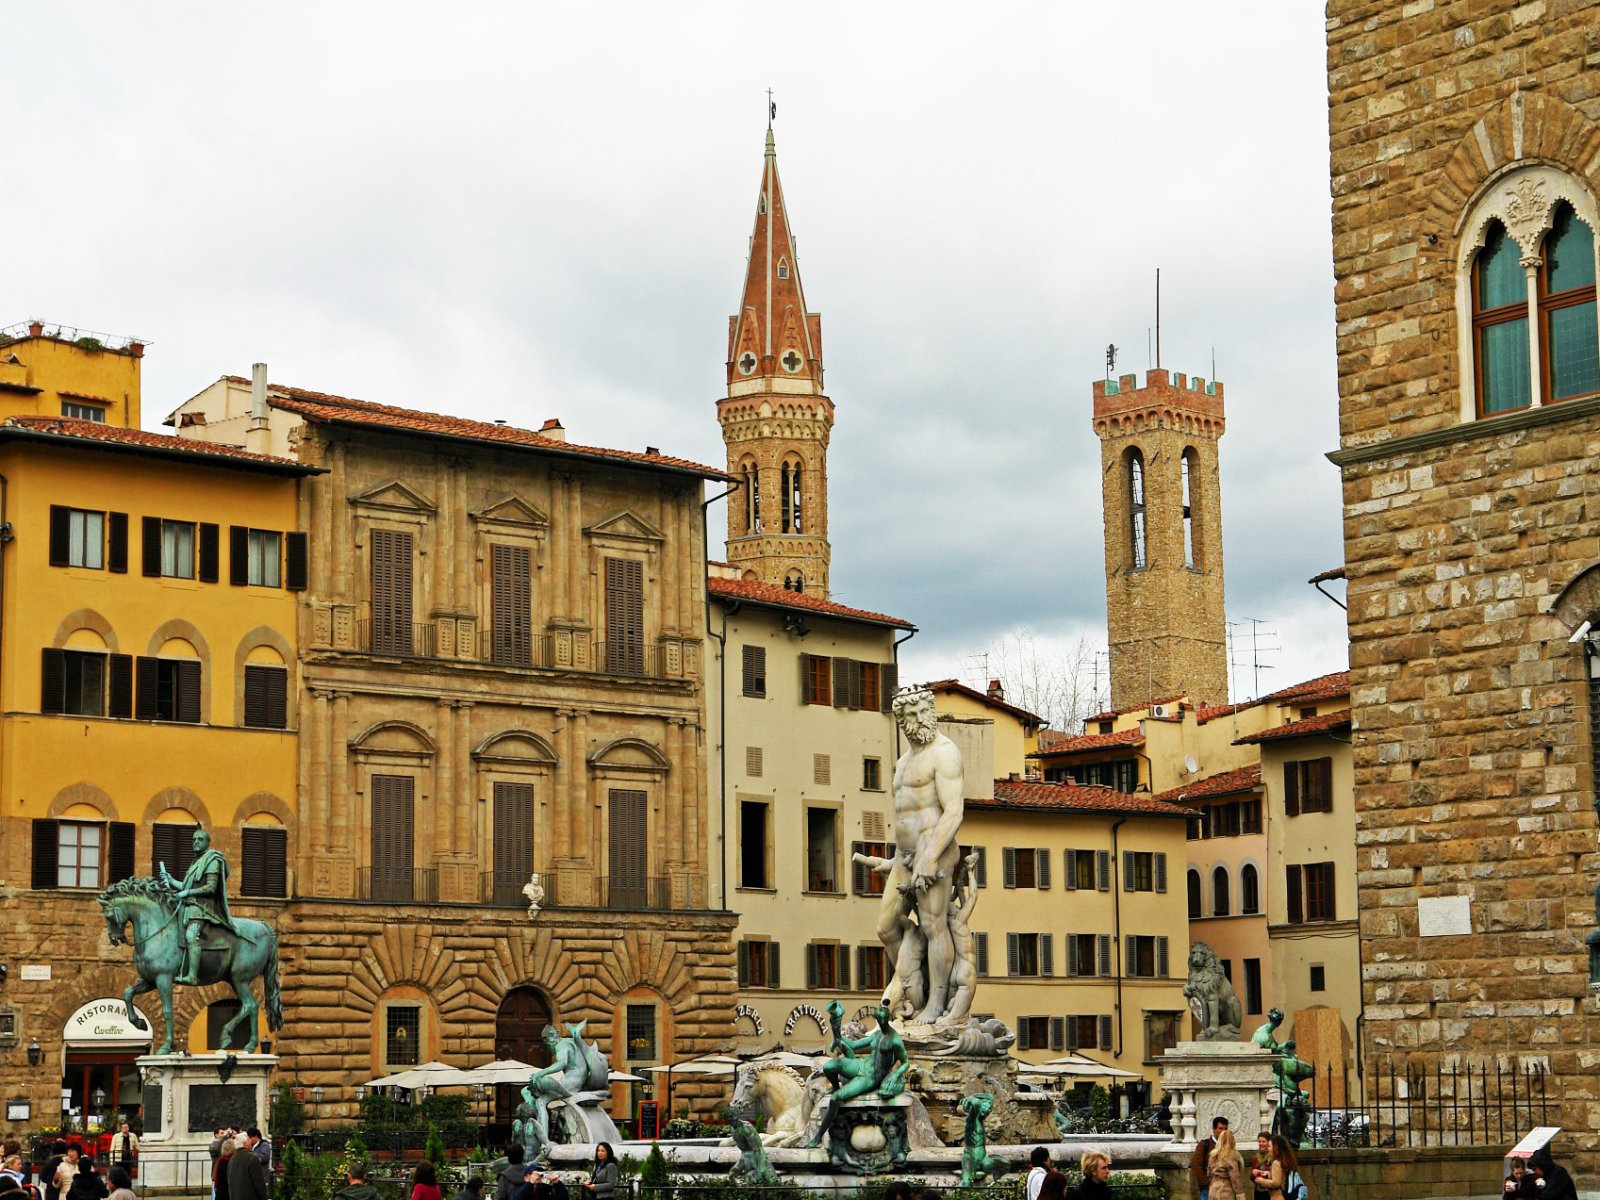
[1301,1058,1552,1147]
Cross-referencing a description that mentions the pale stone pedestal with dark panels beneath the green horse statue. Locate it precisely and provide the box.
[134,1051,278,1192]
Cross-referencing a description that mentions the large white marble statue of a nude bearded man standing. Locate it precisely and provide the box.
[869,688,976,1027]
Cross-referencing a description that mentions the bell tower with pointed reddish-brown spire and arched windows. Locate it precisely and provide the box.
[717,120,834,598]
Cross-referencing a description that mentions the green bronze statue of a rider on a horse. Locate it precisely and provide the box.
[98,827,283,1054]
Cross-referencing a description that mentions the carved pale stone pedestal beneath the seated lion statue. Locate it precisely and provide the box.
[1160,1042,1277,1150]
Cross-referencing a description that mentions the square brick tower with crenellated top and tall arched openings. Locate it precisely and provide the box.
[1094,368,1227,707]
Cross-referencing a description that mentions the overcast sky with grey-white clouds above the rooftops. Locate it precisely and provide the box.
[9,0,1346,723]
